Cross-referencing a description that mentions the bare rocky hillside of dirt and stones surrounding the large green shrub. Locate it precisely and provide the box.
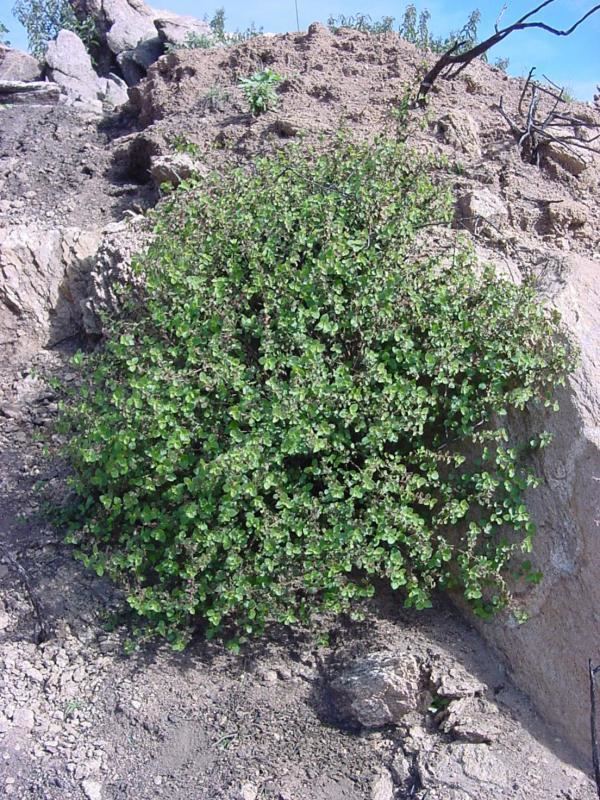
[0,7,600,800]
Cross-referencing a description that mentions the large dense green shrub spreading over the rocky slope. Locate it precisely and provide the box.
[62,137,571,646]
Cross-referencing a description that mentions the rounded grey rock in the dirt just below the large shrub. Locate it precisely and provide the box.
[328,653,428,728]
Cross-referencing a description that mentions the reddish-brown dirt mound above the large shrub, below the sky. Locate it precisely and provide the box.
[130,24,600,262]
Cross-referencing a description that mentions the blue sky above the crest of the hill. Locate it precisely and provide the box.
[0,0,600,100]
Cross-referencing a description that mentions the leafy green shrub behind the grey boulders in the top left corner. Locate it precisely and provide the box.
[13,0,98,58]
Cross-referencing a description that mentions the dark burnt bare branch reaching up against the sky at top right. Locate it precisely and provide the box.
[416,0,600,107]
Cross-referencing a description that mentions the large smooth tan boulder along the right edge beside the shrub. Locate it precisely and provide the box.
[483,251,600,757]
